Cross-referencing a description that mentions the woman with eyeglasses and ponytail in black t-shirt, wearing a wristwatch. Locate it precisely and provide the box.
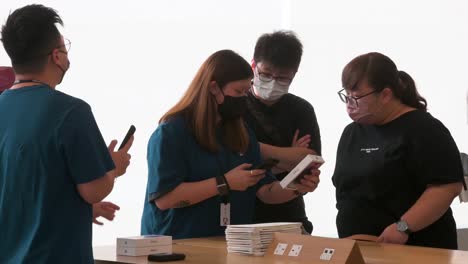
[332,52,463,249]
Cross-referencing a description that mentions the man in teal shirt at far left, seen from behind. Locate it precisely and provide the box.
[0,5,132,264]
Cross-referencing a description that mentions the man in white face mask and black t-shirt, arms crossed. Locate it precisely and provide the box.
[241,31,321,233]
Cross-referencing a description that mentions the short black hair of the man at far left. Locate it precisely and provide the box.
[2,4,63,73]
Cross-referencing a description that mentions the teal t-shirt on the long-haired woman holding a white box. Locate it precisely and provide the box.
[141,117,274,239]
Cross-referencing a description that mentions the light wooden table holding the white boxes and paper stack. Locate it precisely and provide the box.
[94,237,468,264]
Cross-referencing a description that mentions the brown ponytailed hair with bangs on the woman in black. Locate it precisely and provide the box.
[341,52,427,111]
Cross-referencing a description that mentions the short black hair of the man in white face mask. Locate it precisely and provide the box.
[254,30,302,70]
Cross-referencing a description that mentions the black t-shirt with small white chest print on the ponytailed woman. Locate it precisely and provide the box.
[332,110,463,248]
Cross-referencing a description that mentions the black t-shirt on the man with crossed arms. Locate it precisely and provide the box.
[244,93,322,233]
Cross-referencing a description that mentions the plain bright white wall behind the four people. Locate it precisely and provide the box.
[0,0,468,245]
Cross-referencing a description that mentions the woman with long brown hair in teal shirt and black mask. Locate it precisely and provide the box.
[141,50,319,239]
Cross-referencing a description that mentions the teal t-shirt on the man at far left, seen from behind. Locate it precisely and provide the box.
[0,85,114,264]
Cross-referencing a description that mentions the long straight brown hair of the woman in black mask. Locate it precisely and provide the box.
[159,50,253,153]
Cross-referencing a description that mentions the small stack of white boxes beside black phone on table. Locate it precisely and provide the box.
[117,235,172,256]
